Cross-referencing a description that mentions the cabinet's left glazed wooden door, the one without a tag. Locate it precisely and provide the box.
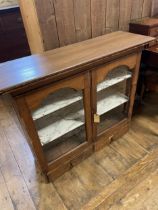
[18,73,91,169]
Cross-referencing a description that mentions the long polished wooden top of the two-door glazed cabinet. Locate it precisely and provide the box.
[0,31,155,94]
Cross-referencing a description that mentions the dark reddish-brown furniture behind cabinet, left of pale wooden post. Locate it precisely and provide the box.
[0,7,30,62]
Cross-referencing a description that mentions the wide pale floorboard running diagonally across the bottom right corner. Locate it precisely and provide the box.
[83,148,158,210]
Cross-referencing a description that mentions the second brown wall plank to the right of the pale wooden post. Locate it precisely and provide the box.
[53,0,76,46]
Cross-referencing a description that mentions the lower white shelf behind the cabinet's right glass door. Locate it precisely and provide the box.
[97,89,128,115]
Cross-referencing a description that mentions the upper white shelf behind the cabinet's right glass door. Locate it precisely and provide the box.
[97,68,132,92]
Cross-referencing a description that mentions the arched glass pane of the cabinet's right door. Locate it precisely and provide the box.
[97,67,131,134]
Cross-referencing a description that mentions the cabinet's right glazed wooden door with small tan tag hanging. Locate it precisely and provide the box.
[92,55,137,139]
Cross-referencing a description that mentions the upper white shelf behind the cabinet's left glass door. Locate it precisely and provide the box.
[32,88,82,120]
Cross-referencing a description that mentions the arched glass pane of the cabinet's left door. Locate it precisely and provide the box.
[32,88,86,161]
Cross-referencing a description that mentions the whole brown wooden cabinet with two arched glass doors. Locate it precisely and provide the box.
[0,32,155,179]
